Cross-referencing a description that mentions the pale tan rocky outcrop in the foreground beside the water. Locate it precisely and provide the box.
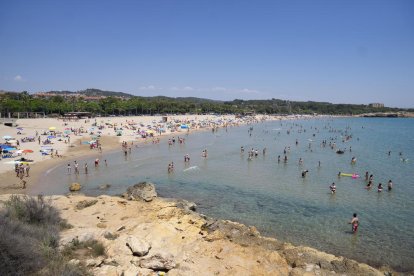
[0,195,392,276]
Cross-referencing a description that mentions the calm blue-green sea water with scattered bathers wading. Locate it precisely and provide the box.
[32,118,414,271]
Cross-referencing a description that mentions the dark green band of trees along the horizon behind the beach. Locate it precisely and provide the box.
[0,89,414,115]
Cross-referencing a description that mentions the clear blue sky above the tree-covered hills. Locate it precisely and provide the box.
[0,0,414,108]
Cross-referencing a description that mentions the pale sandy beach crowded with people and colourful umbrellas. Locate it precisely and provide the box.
[0,115,274,194]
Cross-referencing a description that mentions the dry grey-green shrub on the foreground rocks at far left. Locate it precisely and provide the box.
[0,196,88,276]
